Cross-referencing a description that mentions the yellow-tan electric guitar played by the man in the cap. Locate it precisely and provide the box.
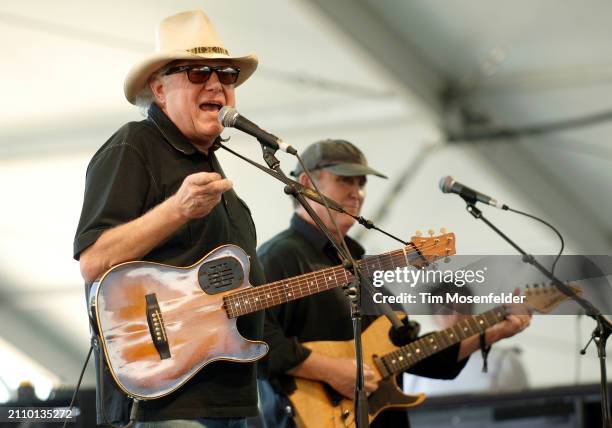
[289,285,581,428]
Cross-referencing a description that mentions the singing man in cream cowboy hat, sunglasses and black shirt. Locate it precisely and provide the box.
[74,11,264,427]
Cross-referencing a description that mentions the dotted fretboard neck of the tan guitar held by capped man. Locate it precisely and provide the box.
[378,306,507,377]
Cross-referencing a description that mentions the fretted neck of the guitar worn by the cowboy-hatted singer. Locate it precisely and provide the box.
[223,244,423,318]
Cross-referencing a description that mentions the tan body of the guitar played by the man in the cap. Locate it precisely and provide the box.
[289,316,425,428]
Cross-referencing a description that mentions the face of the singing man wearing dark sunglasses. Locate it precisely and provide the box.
[151,61,236,151]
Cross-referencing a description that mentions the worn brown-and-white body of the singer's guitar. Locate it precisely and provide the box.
[90,245,268,400]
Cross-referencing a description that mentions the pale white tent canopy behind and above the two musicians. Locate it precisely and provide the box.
[0,0,612,394]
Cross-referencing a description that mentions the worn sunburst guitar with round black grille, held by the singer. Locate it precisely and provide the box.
[89,232,455,400]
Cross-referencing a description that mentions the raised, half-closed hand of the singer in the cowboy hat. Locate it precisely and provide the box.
[172,172,232,220]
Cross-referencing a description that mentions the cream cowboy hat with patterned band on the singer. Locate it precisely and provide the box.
[123,10,257,104]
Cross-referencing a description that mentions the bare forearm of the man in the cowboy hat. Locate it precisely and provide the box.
[79,196,187,283]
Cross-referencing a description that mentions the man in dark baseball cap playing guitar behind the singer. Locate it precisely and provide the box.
[258,140,528,428]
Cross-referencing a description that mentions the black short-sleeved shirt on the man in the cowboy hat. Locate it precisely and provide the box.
[74,104,264,420]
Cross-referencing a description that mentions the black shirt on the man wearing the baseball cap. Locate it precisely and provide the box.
[257,215,467,428]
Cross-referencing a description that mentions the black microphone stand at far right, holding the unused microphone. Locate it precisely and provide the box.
[461,195,612,428]
